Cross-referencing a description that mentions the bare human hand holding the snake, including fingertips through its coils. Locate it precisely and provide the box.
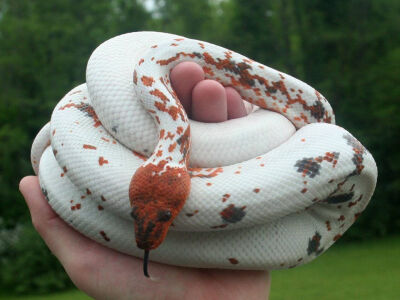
[19,63,270,300]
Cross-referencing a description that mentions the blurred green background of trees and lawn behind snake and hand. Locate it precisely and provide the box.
[0,0,400,299]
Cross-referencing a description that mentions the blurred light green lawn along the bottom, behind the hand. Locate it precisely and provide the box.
[0,237,400,300]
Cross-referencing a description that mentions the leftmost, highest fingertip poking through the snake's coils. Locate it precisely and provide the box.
[170,62,204,117]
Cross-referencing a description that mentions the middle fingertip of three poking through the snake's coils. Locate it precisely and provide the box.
[192,79,228,123]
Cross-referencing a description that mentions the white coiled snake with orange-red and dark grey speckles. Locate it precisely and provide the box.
[31,31,377,276]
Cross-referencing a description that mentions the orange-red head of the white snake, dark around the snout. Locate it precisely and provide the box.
[129,164,190,250]
